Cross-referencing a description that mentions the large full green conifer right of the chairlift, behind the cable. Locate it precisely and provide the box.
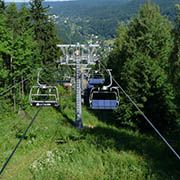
[108,3,177,130]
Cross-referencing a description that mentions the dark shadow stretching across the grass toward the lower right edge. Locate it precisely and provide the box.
[83,126,180,179]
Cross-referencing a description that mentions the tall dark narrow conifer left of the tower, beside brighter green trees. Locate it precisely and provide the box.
[30,0,58,65]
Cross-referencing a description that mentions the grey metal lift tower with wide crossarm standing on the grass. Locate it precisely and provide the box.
[57,43,99,129]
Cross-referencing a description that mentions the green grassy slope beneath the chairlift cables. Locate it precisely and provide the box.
[0,93,180,180]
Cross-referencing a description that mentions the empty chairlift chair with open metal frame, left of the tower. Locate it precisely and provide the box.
[29,69,59,107]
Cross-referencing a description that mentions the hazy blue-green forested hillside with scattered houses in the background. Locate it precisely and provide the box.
[45,0,179,43]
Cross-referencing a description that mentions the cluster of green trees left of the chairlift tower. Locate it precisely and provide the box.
[0,1,59,109]
